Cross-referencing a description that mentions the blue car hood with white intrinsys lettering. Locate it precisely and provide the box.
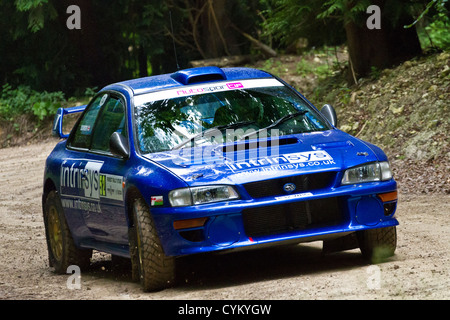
[144,130,386,186]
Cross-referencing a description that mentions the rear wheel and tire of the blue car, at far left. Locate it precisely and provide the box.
[44,191,92,274]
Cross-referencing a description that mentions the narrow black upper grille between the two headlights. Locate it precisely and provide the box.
[244,172,335,199]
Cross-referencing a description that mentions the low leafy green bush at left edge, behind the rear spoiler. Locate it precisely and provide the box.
[0,84,66,124]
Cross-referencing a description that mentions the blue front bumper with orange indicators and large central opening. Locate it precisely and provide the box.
[152,179,398,256]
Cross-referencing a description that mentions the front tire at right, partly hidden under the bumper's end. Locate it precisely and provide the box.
[357,226,397,263]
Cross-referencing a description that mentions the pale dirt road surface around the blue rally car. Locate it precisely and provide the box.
[0,140,450,300]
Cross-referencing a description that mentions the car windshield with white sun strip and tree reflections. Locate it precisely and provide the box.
[134,79,329,153]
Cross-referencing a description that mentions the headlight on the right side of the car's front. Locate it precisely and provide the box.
[341,161,392,185]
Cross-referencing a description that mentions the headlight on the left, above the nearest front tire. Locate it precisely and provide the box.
[169,186,239,207]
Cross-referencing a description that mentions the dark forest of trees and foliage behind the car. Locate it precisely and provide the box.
[0,0,450,152]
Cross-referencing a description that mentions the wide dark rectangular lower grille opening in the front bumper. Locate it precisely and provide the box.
[242,197,343,237]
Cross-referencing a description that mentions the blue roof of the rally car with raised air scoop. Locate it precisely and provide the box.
[102,67,273,95]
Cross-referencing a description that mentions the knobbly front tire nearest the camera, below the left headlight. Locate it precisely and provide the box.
[130,198,175,292]
